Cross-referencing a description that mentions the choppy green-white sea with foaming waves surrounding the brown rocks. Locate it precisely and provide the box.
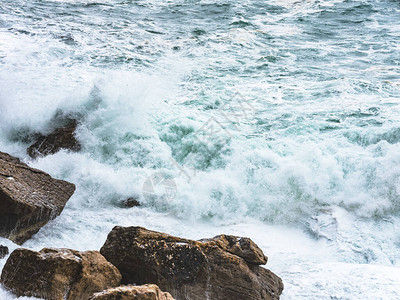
[0,0,400,300]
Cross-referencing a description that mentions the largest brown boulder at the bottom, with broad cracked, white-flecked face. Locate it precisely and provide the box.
[100,226,283,300]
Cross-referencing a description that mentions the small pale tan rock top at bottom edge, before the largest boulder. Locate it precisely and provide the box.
[89,284,174,300]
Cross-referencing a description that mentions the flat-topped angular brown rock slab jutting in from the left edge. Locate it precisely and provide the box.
[0,152,75,244]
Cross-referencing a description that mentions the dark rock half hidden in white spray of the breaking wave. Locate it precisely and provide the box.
[27,120,81,158]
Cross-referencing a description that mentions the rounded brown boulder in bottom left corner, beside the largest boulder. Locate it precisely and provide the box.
[1,248,121,300]
